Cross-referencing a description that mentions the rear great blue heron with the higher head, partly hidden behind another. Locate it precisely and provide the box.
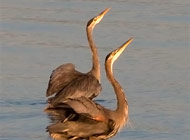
[46,8,110,105]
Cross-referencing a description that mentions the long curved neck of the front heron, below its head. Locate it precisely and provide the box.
[105,62,128,115]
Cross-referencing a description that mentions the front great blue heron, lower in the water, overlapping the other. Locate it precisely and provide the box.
[47,38,133,140]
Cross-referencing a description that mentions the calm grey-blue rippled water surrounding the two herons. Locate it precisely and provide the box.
[0,0,190,140]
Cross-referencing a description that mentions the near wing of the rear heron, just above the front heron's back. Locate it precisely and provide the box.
[49,74,102,105]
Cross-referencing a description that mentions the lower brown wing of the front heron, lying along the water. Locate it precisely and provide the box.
[47,120,109,139]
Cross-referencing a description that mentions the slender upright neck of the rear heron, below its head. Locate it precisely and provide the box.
[86,26,100,82]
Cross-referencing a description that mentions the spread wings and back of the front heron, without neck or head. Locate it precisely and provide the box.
[47,97,114,139]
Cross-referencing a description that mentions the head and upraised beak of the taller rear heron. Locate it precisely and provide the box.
[87,8,111,29]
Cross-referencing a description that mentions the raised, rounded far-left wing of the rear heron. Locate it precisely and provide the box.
[46,63,79,97]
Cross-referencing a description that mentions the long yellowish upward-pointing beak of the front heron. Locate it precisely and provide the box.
[113,37,133,61]
